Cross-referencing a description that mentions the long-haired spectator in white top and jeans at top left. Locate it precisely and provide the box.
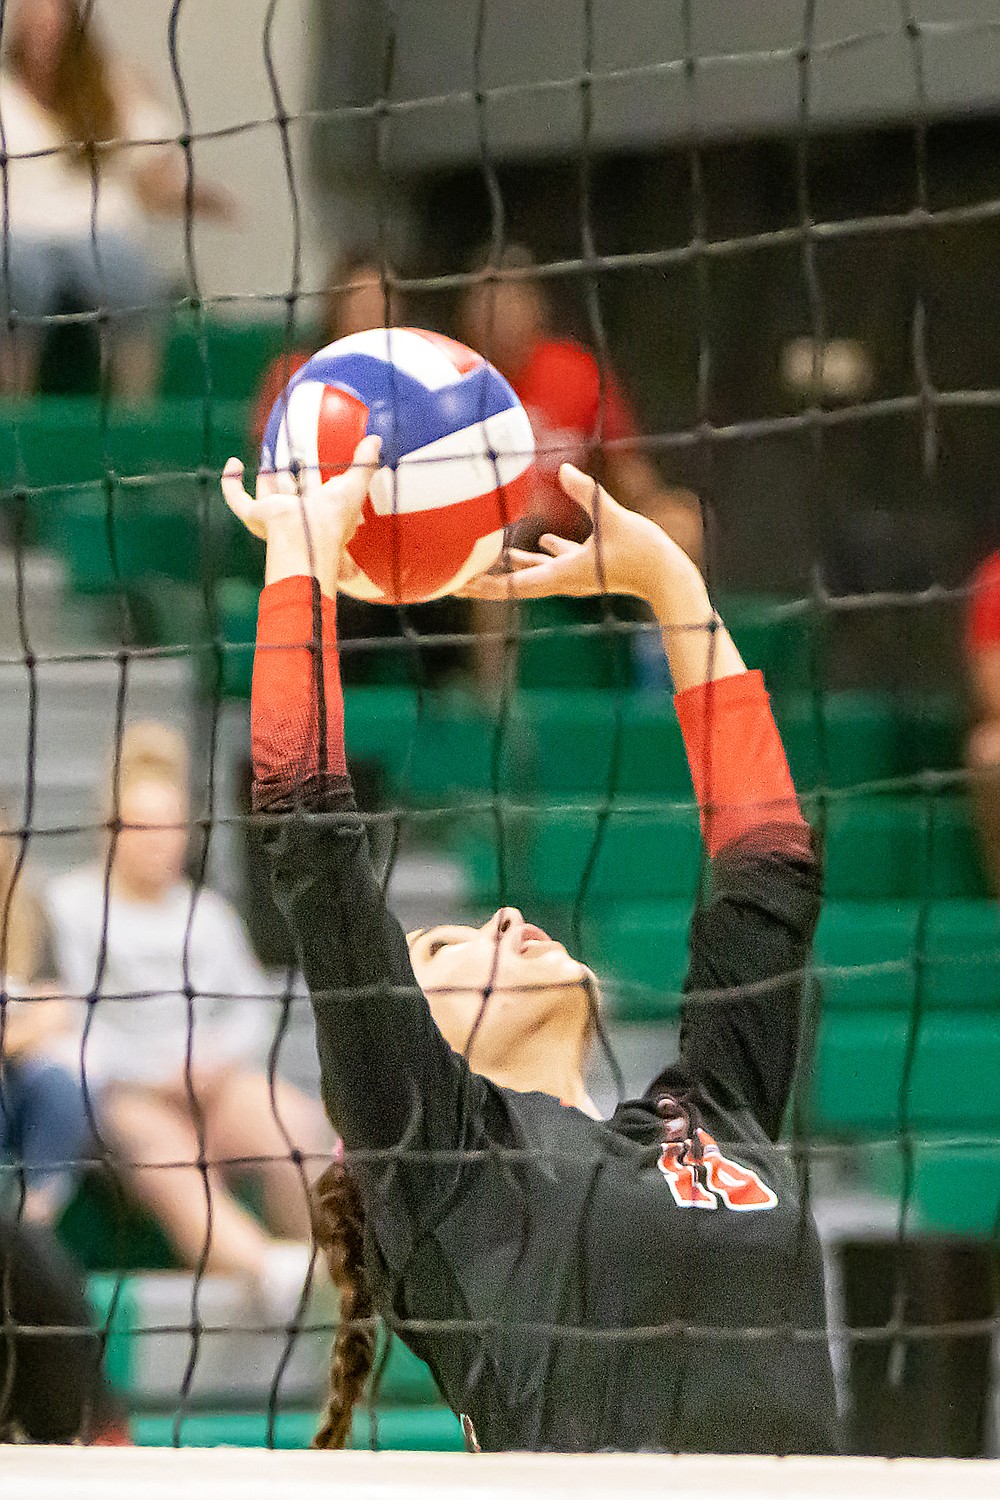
[0,0,234,401]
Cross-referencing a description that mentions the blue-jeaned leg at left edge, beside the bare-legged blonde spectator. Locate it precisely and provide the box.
[6,1058,90,1224]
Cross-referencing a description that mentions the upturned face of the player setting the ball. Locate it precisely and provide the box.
[408,906,594,1076]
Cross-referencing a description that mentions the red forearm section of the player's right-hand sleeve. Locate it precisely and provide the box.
[675,672,810,858]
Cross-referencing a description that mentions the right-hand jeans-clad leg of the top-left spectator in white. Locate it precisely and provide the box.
[72,230,165,402]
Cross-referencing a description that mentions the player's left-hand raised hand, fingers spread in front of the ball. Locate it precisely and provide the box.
[222,437,382,594]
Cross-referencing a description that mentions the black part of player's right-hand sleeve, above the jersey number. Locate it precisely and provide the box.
[671,830,822,1140]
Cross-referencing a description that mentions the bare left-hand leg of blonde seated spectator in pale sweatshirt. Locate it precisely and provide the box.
[102,1088,271,1280]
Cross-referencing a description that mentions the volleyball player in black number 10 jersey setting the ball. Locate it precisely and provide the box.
[223,438,835,1452]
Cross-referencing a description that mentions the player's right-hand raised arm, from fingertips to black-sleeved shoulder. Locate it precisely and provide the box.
[469,465,820,1134]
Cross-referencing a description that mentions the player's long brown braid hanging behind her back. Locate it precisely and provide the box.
[312,1161,376,1448]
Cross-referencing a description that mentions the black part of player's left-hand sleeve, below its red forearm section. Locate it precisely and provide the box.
[265,777,489,1250]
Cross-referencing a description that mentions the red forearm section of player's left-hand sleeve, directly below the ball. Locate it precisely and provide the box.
[250,578,346,806]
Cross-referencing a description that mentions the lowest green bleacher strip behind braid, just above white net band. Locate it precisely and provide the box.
[130,1407,465,1452]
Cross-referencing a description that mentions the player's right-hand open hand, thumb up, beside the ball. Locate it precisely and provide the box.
[462,464,694,600]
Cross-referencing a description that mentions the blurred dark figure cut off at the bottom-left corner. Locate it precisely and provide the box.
[0,1215,129,1446]
